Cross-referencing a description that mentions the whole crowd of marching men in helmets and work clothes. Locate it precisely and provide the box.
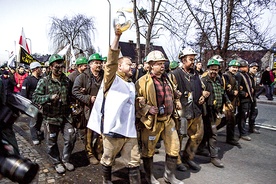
[1,27,274,184]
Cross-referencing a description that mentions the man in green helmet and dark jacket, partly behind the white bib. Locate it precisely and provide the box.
[72,53,104,165]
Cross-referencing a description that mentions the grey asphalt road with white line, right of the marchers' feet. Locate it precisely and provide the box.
[174,104,276,184]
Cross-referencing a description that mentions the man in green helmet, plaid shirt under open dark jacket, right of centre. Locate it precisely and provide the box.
[201,59,233,168]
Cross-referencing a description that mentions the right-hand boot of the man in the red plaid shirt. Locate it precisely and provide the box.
[164,155,184,184]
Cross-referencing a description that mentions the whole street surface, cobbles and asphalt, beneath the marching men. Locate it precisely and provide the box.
[0,104,276,184]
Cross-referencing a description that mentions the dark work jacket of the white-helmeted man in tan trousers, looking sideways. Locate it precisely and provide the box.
[172,68,203,119]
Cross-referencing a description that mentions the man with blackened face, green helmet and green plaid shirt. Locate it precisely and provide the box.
[33,54,76,174]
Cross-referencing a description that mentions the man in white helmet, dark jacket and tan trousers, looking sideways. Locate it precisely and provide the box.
[172,48,209,170]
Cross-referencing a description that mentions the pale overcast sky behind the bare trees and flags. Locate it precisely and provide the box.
[0,0,276,64]
